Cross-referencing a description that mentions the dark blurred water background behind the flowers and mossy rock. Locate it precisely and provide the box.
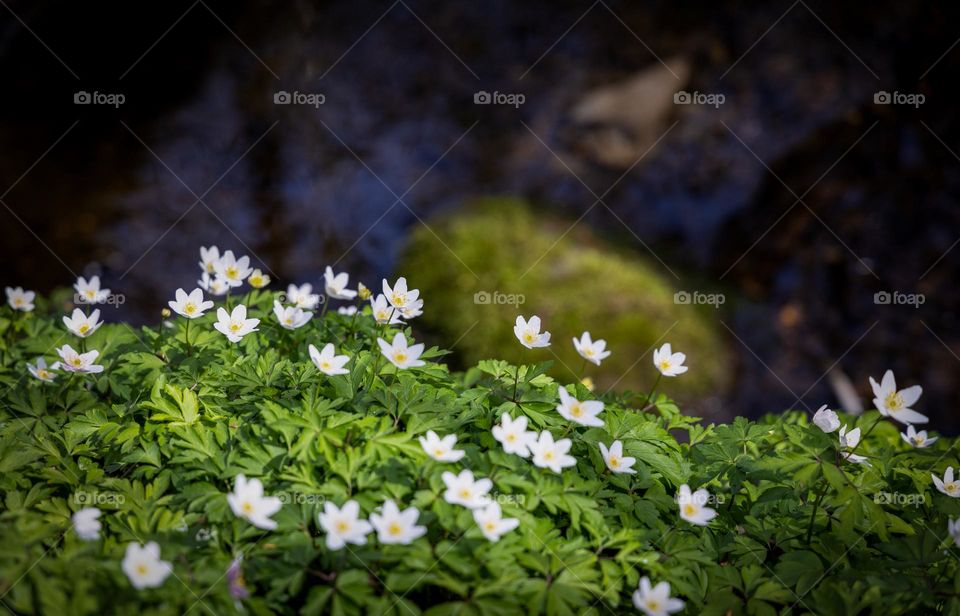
[0,0,960,434]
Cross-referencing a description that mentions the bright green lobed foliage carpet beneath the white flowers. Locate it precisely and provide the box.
[0,292,960,616]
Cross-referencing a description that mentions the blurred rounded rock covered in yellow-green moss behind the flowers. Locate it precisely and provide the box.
[399,198,732,402]
